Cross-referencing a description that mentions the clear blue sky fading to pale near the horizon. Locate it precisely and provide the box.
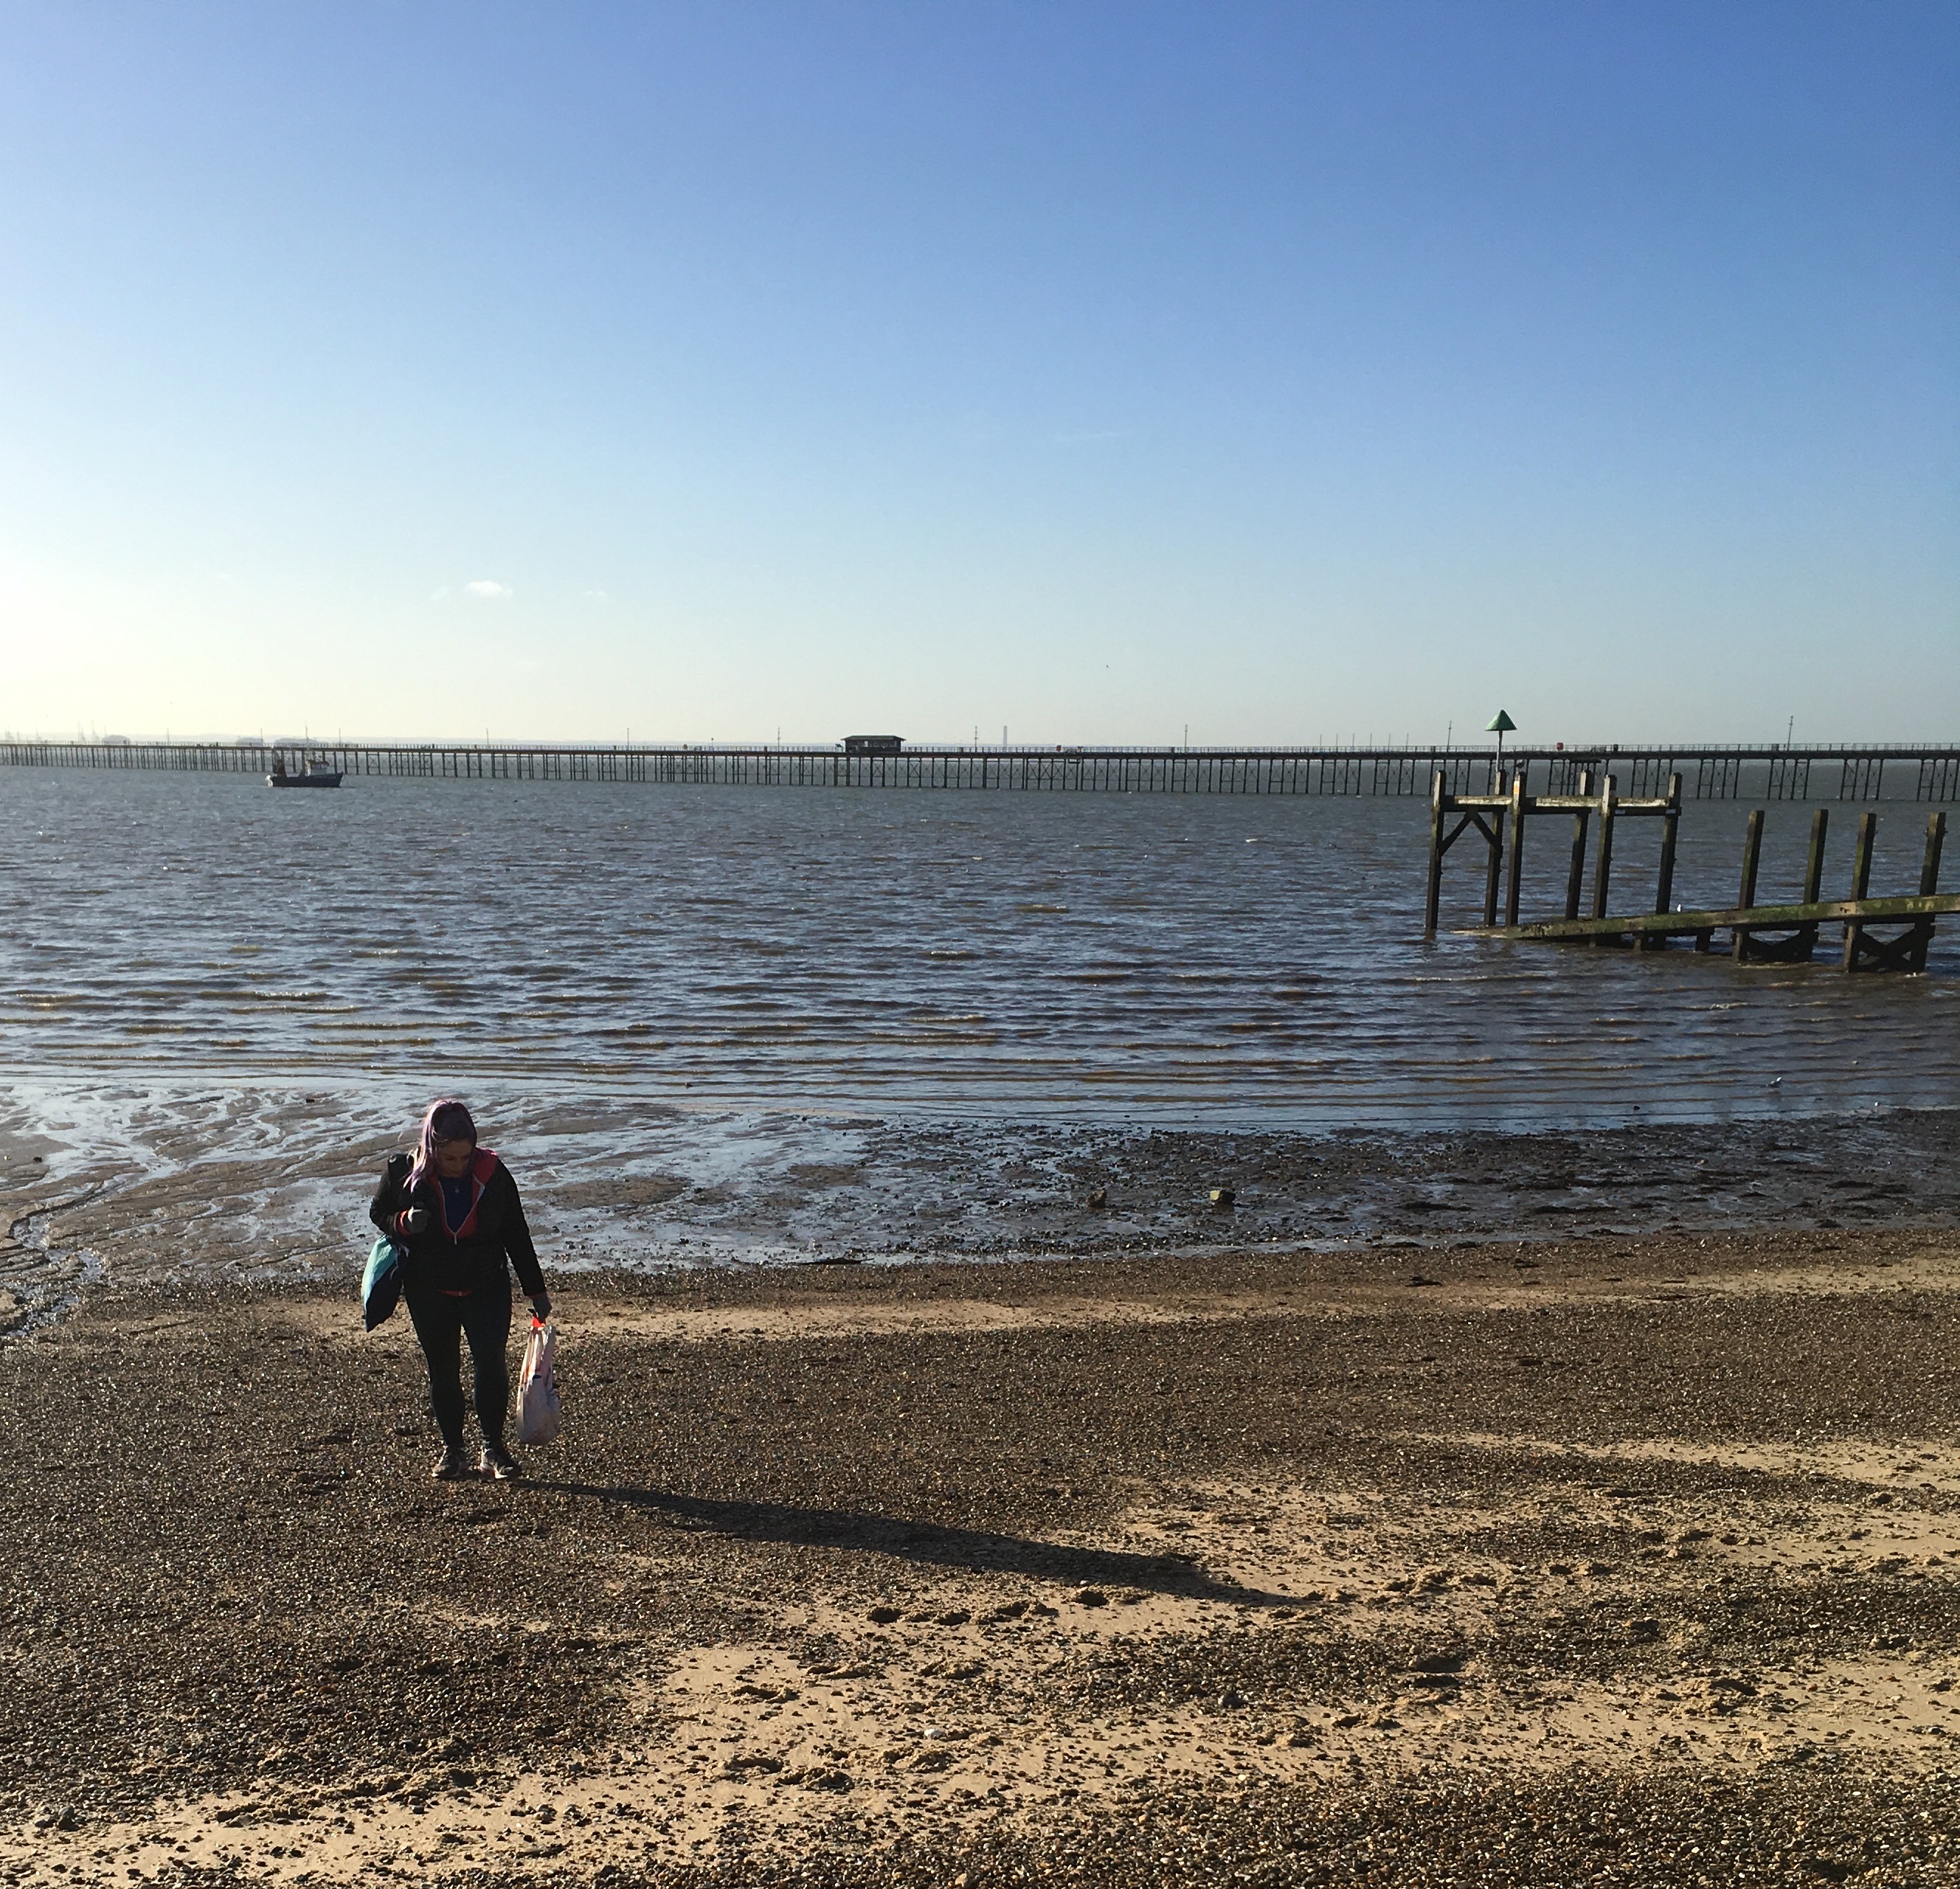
[0,0,1960,745]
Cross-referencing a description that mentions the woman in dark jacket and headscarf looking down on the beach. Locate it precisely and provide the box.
[369,1099,551,1481]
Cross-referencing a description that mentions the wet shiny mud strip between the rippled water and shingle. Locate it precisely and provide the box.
[0,1093,1960,1331]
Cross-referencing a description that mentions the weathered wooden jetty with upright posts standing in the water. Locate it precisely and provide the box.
[1423,766,1960,970]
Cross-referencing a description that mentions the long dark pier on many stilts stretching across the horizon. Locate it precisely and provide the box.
[0,739,1960,803]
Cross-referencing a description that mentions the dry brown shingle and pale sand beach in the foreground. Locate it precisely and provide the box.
[0,1215,1960,1889]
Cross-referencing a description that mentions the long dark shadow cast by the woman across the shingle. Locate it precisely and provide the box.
[517,1481,1300,1606]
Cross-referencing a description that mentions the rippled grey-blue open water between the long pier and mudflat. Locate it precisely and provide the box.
[0,770,1960,1127]
